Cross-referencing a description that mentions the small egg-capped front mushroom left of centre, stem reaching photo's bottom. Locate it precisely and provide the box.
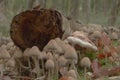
[45,59,55,80]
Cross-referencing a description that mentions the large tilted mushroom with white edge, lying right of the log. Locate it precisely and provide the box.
[67,31,98,51]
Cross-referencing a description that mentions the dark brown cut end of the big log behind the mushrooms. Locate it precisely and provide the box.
[10,9,63,50]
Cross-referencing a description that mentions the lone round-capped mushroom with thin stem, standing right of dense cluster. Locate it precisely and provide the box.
[81,57,91,80]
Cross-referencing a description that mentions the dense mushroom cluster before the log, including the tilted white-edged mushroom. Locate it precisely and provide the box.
[0,31,97,80]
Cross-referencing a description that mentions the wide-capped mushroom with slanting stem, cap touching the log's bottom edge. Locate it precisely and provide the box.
[23,46,41,77]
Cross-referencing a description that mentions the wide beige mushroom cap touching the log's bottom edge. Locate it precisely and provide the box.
[23,46,41,57]
